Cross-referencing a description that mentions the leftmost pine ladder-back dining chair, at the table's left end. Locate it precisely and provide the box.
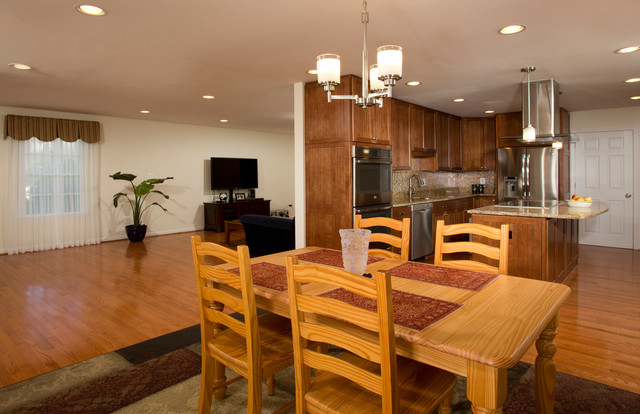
[191,236,295,414]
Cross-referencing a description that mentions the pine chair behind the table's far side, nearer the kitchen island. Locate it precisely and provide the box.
[433,220,509,275]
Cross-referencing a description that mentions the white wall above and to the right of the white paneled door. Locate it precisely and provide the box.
[571,106,640,249]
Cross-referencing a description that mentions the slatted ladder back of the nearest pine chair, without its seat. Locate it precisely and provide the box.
[287,256,398,414]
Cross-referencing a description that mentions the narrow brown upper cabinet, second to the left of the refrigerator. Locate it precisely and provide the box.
[436,112,462,171]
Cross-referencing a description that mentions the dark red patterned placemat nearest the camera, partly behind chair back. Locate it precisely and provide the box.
[319,288,463,332]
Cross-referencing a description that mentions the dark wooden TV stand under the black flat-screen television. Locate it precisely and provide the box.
[204,198,271,233]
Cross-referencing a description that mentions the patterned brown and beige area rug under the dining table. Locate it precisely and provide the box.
[0,325,640,414]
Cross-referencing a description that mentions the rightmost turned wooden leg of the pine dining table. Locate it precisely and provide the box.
[536,315,558,414]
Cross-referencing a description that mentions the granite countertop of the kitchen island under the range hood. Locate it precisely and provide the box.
[467,201,609,220]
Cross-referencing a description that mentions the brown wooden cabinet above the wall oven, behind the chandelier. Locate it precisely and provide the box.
[305,75,390,146]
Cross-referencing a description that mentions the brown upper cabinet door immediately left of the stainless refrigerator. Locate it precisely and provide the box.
[462,118,496,171]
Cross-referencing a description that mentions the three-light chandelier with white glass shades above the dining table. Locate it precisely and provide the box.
[316,1,402,108]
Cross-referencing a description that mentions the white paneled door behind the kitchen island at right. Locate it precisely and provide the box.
[574,130,634,249]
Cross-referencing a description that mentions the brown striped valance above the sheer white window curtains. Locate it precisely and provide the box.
[4,115,100,144]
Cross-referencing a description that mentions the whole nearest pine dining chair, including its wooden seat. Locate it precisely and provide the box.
[287,256,456,414]
